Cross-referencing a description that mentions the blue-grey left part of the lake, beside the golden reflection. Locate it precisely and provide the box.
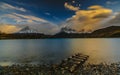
[0,39,70,63]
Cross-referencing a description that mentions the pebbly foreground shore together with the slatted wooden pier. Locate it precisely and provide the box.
[0,53,120,75]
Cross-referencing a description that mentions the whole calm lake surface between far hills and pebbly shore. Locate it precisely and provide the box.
[0,38,120,65]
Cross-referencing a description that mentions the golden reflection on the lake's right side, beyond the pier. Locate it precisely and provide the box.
[71,39,120,63]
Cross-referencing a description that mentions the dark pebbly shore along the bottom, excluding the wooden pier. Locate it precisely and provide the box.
[0,63,120,75]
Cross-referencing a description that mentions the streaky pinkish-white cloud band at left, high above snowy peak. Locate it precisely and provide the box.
[0,13,48,23]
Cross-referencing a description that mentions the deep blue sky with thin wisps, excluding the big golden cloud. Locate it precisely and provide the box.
[0,0,120,24]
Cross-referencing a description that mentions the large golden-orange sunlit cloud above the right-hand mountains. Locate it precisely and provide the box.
[65,5,112,32]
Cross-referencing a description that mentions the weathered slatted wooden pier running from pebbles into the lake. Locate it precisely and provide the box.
[59,53,89,73]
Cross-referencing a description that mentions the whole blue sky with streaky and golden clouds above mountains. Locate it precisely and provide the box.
[0,0,120,33]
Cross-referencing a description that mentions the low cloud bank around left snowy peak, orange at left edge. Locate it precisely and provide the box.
[0,23,60,35]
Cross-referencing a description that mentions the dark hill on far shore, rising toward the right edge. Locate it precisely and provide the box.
[54,26,120,38]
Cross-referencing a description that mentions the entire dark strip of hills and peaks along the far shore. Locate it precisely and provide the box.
[0,26,120,39]
